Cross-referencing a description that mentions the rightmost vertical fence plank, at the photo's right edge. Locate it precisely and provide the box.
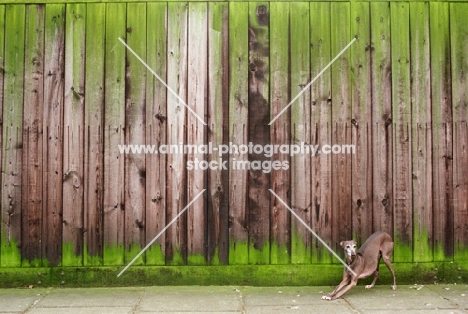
[450,3,468,261]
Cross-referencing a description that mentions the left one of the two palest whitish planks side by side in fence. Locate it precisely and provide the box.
[166,2,186,265]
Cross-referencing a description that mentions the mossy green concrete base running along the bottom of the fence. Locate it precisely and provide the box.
[0,262,468,288]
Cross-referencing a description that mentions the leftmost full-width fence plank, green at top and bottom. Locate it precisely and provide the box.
[0,5,25,267]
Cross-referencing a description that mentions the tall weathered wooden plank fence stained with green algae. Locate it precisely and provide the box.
[0,1,468,267]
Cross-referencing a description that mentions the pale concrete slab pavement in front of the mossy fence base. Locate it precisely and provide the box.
[0,284,468,314]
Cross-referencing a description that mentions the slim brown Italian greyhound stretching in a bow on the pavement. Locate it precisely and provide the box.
[322,232,396,300]
